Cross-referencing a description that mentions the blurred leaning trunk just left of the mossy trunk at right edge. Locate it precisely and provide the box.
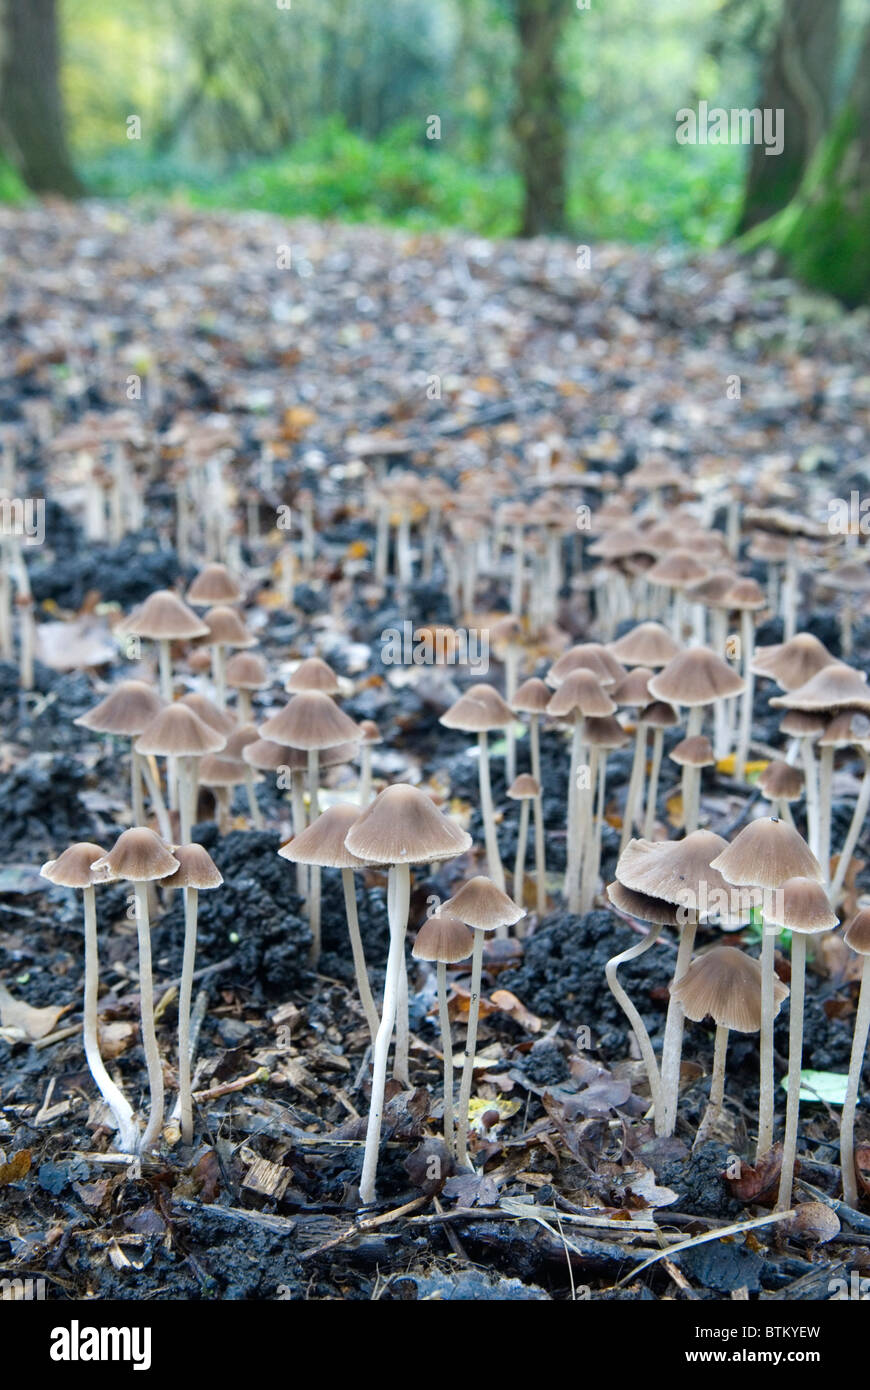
[737,0,841,232]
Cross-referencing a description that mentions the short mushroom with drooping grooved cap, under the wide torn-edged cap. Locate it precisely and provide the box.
[671,945,788,1148]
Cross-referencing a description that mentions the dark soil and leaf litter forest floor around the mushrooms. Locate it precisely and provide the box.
[0,203,870,1300]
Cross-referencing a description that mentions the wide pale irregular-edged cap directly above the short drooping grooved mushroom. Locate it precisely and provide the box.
[616,830,756,926]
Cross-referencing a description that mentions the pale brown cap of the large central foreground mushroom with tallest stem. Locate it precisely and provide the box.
[345,783,471,865]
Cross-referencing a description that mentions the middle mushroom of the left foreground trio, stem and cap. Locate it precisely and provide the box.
[90,826,179,1154]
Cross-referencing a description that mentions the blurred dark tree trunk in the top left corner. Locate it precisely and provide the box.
[0,0,82,197]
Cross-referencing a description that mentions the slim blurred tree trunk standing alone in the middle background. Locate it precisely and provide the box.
[511,0,568,236]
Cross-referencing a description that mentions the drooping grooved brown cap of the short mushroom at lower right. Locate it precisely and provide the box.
[671,947,788,1033]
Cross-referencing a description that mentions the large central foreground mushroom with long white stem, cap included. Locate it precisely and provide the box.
[341,783,471,1204]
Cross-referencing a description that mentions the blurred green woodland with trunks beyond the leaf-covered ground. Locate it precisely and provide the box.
[0,0,870,302]
